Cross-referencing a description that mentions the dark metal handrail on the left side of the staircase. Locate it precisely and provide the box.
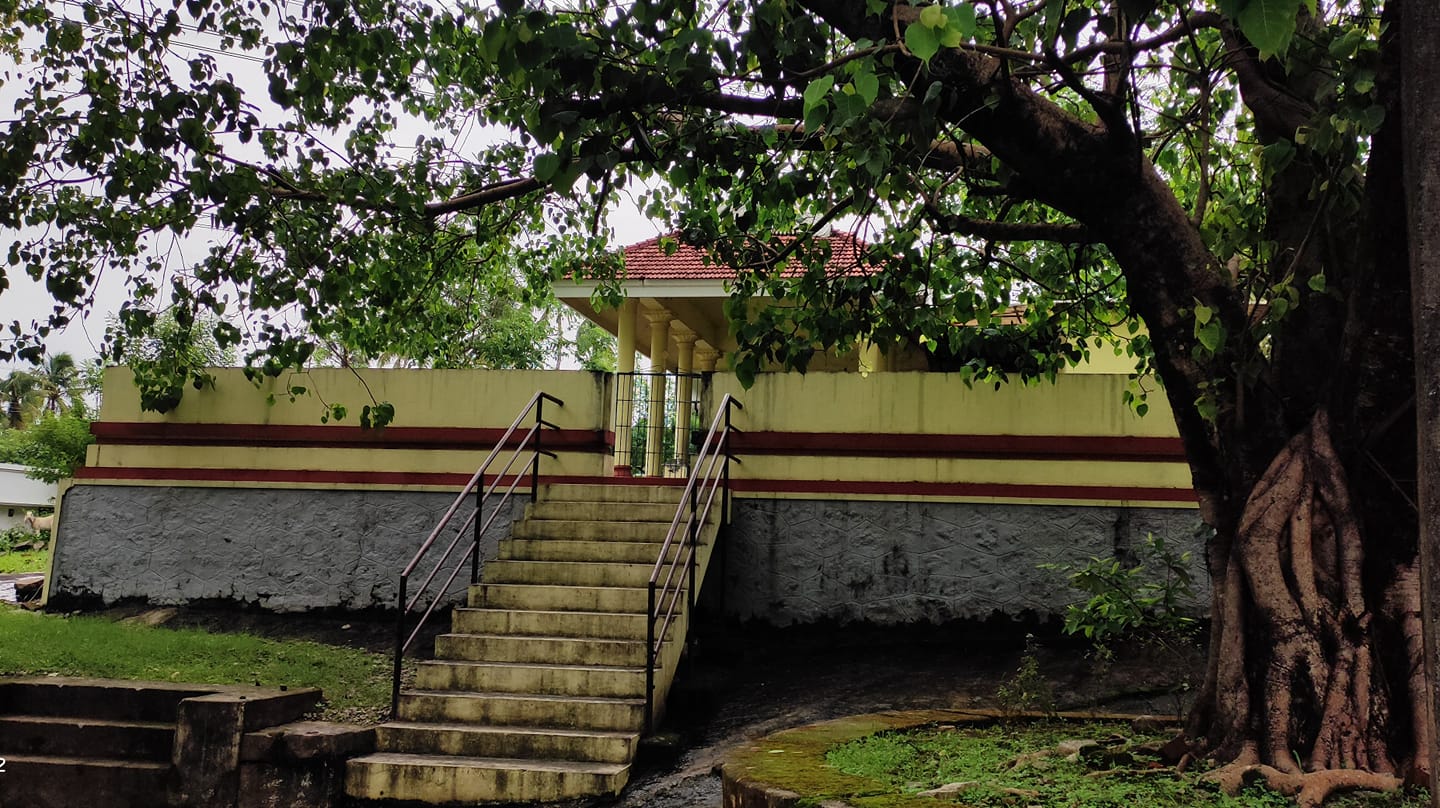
[390,392,564,717]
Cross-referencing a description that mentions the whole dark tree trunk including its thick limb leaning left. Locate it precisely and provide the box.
[804,0,1431,789]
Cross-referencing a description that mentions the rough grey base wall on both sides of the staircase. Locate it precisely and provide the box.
[50,485,1208,625]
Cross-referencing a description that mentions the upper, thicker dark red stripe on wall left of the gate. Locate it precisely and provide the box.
[91,421,609,454]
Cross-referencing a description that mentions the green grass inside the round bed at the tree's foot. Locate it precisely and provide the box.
[825,722,1430,808]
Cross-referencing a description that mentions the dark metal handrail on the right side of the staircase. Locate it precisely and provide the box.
[645,393,744,735]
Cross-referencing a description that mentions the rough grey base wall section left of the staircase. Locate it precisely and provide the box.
[49,485,510,612]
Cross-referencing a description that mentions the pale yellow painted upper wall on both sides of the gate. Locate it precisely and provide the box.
[85,369,1189,503]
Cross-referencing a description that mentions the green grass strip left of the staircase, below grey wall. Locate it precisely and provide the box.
[0,608,390,723]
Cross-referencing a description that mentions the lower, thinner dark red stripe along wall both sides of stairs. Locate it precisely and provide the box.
[75,467,1195,503]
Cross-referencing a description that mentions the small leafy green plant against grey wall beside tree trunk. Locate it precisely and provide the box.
[1041,534,1200,714]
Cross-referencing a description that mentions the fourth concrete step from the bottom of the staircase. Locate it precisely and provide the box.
[415,660,645,699]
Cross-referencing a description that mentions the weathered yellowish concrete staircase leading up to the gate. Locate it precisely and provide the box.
[346,485,719,805]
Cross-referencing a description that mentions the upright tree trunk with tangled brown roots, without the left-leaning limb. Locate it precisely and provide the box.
[1188,3,1434,805]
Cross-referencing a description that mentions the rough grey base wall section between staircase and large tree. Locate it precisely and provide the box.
[714,498,1208,625]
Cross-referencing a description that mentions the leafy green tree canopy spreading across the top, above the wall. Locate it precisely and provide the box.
[0,0,1378,409]
